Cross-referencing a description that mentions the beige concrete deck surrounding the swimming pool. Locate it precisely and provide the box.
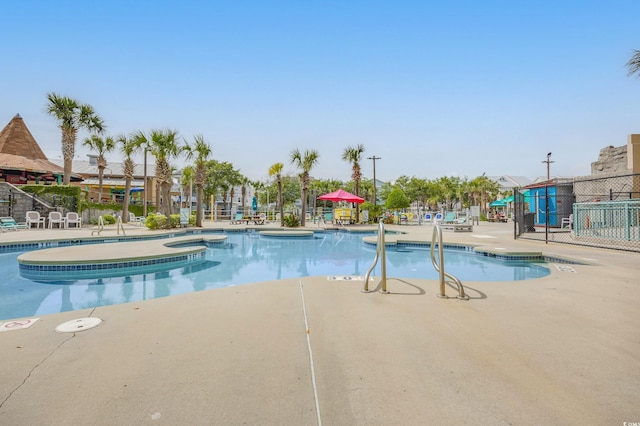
[0,222,640,425]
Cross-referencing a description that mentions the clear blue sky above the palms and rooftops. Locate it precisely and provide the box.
[0,0,640,180]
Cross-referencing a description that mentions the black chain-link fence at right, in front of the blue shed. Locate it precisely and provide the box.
[513,174,640,252]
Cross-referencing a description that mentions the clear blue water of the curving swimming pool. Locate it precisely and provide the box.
[0,232,549,320]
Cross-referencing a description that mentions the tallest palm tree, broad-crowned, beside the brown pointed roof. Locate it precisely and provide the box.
[46,92,105,185]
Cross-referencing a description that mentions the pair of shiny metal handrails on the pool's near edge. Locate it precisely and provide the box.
[362,220,469,300]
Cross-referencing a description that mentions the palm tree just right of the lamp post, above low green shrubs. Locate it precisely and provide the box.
[149,129,182,221]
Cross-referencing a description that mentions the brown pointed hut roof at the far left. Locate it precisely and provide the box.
[0,114,69,174]
